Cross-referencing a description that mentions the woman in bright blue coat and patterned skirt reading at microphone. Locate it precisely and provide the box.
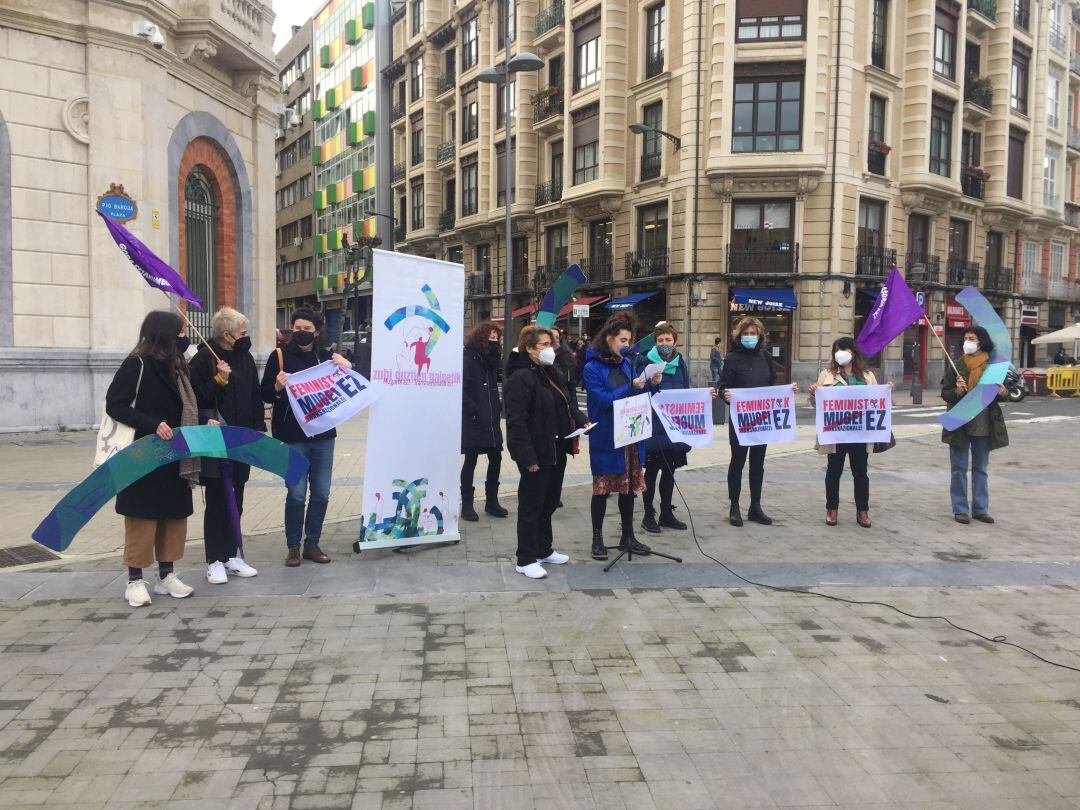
[583,314,663,559]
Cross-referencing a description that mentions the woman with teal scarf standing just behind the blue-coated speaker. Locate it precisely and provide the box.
[642,323,716,535]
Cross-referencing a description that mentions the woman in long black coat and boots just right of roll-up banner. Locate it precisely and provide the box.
[461,321,510,521]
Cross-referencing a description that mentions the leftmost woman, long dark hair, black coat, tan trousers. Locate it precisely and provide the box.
[105,310,199,607]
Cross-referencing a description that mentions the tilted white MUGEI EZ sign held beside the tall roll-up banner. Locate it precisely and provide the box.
[285,360,378,436]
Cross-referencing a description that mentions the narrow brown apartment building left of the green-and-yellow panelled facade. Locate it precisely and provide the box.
[274,19,318,328]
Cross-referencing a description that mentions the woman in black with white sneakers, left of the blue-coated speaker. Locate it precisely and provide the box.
[504,326,588,579]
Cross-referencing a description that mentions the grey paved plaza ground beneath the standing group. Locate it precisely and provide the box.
[0,401,1080,810]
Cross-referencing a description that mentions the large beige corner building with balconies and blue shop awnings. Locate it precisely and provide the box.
[383,0,1080,387]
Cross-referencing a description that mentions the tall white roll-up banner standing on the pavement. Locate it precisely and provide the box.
[355,251,464,551]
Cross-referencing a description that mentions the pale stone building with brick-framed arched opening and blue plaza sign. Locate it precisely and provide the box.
[0,0,279,430]
